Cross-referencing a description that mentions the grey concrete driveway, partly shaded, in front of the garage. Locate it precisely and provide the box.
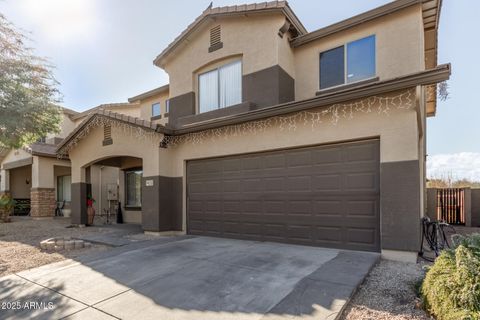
[0,237,379,320]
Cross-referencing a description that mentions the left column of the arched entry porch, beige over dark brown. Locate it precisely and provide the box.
[70,162,91,225]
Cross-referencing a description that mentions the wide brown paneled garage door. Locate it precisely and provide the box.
[187,140,380,251]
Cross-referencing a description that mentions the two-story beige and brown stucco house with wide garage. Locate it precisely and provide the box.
[49,0,450,260]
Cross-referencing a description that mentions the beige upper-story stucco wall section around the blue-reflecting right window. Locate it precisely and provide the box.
[295,5,425,100]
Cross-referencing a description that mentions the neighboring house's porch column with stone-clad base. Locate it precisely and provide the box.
[30,156,56,218]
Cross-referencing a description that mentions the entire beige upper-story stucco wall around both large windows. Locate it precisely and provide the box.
[160,5,425,104]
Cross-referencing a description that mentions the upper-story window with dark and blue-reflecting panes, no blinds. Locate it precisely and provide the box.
[320,35,376,89]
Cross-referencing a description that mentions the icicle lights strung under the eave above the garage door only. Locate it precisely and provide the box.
[162,89,415,147]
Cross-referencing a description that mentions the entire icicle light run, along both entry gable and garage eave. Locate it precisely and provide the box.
[59,89,415,157]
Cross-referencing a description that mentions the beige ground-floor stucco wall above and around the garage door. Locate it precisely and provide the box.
[160,89,419,229]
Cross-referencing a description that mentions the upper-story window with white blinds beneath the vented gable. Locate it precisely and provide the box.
[198,61,242,113]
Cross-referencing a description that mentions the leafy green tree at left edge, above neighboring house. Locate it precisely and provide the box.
[0,14,61,148]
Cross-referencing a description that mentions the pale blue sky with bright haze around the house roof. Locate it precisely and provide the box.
[0,0,480,180]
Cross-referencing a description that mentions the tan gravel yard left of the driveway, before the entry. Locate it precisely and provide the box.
[0,217,124,277]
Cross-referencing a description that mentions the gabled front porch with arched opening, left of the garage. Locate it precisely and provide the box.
[58,112,183,232]
